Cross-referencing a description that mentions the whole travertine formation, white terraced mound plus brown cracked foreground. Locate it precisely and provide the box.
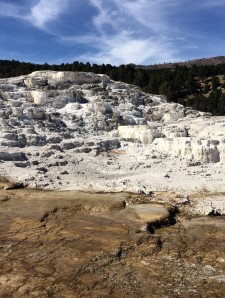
[0,71,225,298]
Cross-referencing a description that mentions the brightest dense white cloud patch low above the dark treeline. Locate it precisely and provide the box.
[73,31,176,65]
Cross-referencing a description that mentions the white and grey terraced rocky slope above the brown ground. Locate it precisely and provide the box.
[0,71,225,206]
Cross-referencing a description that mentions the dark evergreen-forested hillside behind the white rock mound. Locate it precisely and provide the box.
[0,60,225,115]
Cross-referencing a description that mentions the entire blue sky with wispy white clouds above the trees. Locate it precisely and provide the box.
[0,0,225,65]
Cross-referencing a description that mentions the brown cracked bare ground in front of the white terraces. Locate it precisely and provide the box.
[0,185,225,298]
